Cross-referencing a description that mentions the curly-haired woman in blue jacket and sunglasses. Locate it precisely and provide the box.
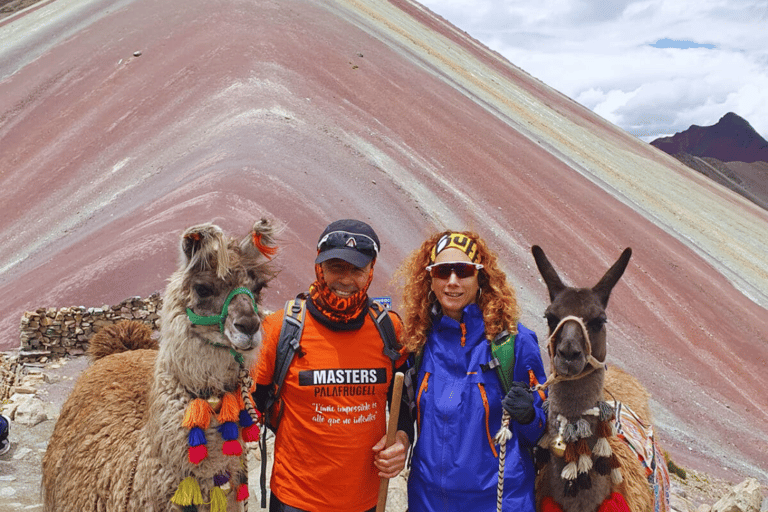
[401,232,546,512]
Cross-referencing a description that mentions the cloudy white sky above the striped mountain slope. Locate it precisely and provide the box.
[419,0,768,142]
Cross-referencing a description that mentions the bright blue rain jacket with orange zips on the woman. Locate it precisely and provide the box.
[408,304,546,512]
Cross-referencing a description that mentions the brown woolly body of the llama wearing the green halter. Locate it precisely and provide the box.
[42,350,157,511]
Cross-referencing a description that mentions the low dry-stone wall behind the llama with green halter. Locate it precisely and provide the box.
[19,293,162,362]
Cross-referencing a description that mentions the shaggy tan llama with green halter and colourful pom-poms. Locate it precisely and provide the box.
[42,219,276,512]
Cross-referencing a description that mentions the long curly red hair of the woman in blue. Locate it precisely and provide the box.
[397,231,519,352]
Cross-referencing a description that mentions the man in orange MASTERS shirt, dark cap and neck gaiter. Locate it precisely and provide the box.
[255,219,413,512]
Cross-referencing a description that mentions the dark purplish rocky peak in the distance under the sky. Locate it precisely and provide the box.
[651,112,768,163]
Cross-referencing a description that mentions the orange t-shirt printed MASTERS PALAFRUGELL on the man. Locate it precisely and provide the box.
[256,310,402,512]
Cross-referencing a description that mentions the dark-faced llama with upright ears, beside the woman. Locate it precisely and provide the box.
[532,246,668,512]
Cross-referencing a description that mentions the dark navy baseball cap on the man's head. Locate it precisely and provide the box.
[315,219,380,268]
